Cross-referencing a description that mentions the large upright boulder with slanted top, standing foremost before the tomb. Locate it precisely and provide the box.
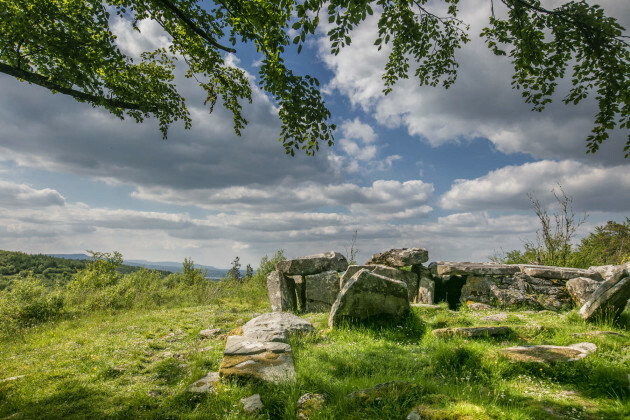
[328,269,409,327]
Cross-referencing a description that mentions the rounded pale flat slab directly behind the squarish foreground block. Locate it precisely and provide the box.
[241,312,315,343]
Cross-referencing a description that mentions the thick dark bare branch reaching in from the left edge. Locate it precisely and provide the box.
[0,63,158,112]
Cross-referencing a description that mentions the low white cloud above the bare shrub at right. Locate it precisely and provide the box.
[439,160,630,211]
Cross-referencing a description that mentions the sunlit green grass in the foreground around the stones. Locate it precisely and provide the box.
[0,276,630,420]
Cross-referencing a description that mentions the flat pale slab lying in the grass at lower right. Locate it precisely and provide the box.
[501,343,597,363]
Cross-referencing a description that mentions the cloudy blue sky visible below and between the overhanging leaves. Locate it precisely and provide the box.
[0,0,630,268]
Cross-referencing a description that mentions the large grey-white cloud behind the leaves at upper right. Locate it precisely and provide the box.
[319,0,630,163]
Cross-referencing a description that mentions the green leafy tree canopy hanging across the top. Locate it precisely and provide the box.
[0,0,630,156]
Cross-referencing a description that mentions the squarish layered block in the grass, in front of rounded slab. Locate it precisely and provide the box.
[219,335,295,383]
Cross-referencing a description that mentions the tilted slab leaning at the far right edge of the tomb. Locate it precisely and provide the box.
[579,269,630,320]
